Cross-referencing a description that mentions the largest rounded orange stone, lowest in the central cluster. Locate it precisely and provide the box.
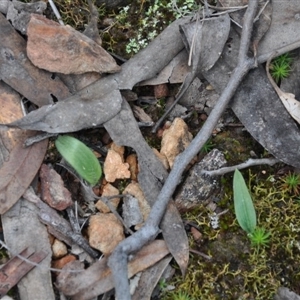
[88,213,125,255]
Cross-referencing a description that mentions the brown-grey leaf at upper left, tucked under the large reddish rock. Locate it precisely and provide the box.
[0,13,70,106]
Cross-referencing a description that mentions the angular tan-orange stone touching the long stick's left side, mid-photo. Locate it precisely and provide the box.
[160,118,193,168]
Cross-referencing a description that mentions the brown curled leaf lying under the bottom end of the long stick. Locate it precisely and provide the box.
[57,240,169,300]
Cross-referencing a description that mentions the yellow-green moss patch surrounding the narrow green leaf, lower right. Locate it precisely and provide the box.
[162,172,300,300]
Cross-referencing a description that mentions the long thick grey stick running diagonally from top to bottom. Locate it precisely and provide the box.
[108,0,258,300]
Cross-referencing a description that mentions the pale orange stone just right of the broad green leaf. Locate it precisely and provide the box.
[103,149,130,182]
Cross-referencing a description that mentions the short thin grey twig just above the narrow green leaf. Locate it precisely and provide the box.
[202,158,279,176]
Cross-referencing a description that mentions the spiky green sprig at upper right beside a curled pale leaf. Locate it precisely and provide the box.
[270,53,293,83]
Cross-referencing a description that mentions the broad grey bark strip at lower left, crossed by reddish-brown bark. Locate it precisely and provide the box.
[1,198,55,300]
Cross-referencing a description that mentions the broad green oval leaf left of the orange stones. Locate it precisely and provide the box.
[55,135,102,186]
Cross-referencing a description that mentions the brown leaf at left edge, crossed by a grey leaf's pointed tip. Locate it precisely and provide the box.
[0,81,48,214]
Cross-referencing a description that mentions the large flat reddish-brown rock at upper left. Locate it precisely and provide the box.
[27,14,120,74]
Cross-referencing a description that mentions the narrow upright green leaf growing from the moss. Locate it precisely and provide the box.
[233,169,256,233]
